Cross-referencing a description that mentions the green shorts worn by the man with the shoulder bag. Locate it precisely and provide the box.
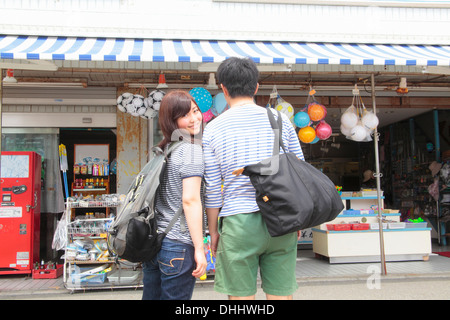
[214,212,298,297]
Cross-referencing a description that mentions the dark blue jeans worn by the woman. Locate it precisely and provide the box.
[142,238,196,300]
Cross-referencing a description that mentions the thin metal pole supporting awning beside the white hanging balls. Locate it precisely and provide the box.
[371,73,387,275]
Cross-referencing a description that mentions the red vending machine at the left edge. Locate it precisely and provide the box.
[0,151,41,275]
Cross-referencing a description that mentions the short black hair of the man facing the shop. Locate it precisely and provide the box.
[217,57,259,98]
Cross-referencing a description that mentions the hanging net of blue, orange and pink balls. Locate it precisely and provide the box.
[294,88,333,144]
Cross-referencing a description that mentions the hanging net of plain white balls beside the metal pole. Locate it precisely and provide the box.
[340,85,379,142]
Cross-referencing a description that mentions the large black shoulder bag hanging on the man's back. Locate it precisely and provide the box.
[241,108,344,237]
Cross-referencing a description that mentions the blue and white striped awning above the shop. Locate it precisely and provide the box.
[0,35,450,67]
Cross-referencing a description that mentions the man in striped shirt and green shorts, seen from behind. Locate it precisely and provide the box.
[203,58,304,299]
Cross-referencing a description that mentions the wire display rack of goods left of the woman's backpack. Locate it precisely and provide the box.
[63,195,142,292]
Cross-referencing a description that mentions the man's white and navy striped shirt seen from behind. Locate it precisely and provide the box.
[203,104,304,217]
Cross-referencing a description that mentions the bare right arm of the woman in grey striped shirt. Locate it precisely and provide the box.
[182,176,207,278]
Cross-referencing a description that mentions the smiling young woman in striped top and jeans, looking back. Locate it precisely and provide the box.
[142,90,207,300]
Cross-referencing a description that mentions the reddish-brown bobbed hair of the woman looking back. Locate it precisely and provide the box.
[158,90,200,150]
